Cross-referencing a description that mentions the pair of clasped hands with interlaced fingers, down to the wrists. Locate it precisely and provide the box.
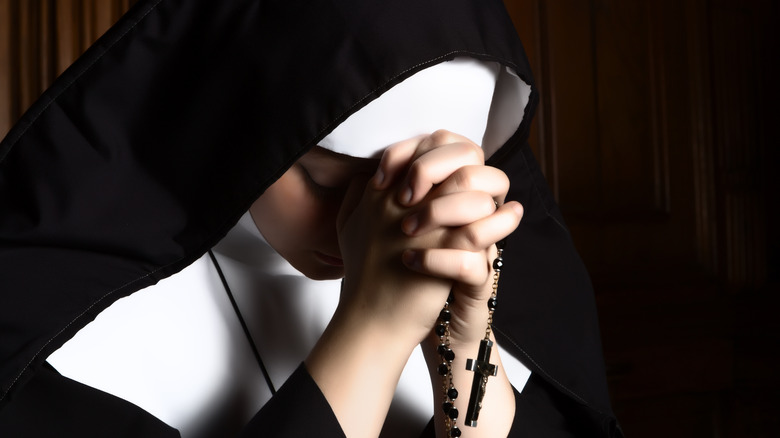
[338,131,522,345]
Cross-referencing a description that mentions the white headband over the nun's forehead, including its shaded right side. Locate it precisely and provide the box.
[319,57,531,158]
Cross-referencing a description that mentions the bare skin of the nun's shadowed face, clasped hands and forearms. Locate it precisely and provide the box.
[250,131,523,437]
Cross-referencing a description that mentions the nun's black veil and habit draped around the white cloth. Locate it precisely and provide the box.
[0,0,620,436]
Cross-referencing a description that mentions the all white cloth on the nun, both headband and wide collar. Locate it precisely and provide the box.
[49,59,530,438]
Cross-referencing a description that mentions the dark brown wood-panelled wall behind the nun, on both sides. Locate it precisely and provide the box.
[0,0,780,438]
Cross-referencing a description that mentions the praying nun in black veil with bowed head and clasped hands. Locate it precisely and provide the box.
[0,0,622,438]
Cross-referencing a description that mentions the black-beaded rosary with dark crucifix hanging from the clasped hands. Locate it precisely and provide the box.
[436,240,505,437]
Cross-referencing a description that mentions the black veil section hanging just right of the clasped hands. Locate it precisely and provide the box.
[494,144,621,436]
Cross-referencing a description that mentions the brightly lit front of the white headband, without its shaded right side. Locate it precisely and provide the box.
[319,58,499,158]
